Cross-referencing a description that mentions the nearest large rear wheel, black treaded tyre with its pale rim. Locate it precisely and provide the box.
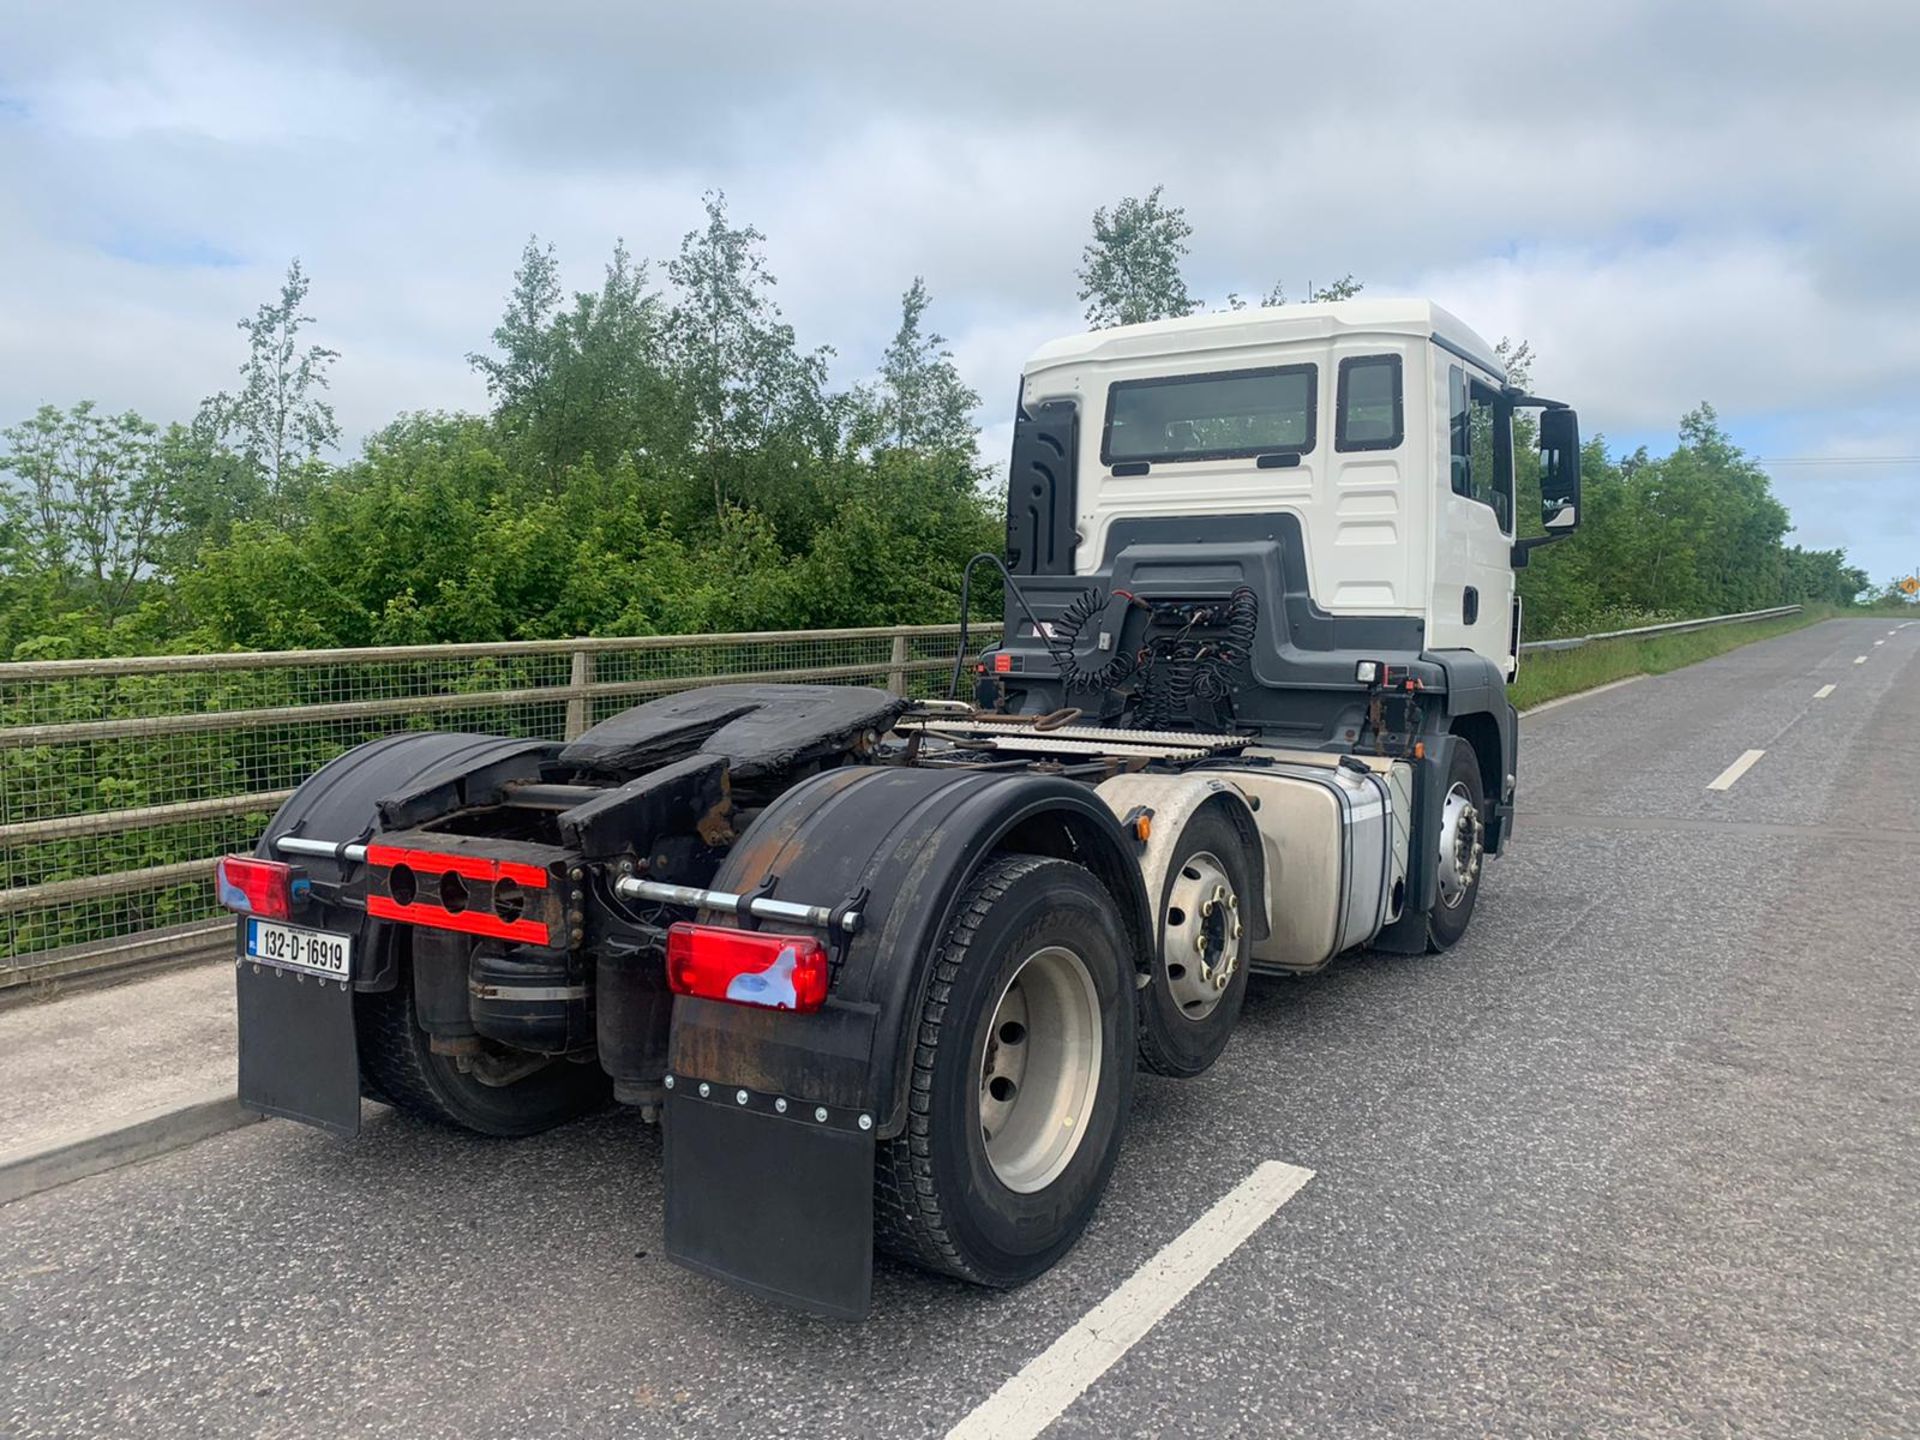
[874,854,1135,1286]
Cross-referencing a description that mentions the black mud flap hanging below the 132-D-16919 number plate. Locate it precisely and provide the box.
[238,960,359,1139]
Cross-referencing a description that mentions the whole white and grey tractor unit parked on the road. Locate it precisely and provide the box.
[217,300,1580,1317]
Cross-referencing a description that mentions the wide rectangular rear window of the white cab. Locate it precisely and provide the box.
[1100,365,1317,465]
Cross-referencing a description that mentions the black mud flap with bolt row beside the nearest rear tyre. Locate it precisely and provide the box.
[664,1075,874,1319]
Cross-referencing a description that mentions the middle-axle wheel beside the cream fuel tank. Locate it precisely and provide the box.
[1139,808,1252,1079]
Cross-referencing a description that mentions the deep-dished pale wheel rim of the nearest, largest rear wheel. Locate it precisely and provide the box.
[979,945,1100,1194]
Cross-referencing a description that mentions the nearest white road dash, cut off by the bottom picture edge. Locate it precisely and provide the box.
[947,1160,1313,1440]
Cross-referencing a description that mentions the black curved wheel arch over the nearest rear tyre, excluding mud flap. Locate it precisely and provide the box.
[668,766,1152,1139]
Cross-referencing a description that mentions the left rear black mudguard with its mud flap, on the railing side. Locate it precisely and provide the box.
[234,732,559,1137]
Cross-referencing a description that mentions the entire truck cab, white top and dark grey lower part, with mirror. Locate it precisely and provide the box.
[975,300,1578,945]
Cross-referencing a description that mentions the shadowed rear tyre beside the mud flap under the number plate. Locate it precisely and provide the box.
[353,948,611,1137]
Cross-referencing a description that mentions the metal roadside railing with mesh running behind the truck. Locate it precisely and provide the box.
[0,605,1801,996]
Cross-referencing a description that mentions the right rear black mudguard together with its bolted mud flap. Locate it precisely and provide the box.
[666,766,1152,1317]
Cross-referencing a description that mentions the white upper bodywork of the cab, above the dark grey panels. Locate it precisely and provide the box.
[1014,300,1572,674]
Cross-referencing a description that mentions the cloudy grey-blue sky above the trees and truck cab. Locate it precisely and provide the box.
[0,0,1920,578]
